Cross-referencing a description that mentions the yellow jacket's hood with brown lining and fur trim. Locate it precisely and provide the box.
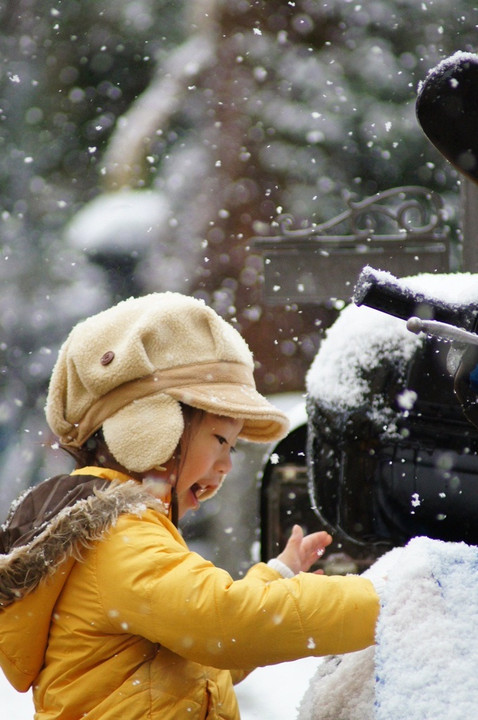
[0,468,168,690]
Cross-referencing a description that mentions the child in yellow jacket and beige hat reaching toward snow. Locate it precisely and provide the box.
[0,293,379,720]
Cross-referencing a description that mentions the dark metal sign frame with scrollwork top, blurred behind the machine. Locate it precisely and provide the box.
[251,185,450,304]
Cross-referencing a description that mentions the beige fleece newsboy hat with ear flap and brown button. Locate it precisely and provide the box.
[46,292,289,472]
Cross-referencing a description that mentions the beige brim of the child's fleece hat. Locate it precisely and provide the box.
[165,383,290,443]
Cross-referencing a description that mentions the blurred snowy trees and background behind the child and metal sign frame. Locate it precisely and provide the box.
[0,0,478,574]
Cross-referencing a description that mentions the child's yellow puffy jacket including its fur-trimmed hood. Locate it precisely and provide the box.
[0,468,379,720]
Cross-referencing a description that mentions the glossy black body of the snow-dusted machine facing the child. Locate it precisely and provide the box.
[307,268,478,553]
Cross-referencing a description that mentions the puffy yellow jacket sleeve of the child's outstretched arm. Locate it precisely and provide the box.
[94,511,379,669]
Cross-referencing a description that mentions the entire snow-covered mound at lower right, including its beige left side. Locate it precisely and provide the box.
[298,537,478,720]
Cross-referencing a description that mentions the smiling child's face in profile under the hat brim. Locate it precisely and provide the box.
[176,413,243,518]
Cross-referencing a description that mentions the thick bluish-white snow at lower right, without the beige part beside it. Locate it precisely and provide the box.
[375,538,478,720]
